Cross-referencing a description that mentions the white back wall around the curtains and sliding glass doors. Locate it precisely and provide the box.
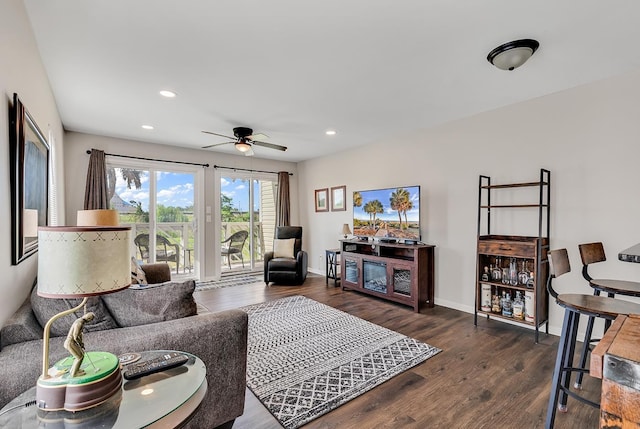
[65,132,299,278]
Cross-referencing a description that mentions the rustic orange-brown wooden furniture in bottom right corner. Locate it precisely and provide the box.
[590,315,640,428]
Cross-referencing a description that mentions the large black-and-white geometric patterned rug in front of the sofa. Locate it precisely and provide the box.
[242,296,441,429]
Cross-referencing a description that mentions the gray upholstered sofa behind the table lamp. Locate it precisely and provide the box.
[0,264,248,429]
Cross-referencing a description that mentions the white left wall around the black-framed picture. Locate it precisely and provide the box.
[0,0,64,325]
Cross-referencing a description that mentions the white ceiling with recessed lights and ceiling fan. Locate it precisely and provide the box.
[25,0,640,162]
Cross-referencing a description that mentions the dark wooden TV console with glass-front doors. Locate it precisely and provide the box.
[340,239,435,312]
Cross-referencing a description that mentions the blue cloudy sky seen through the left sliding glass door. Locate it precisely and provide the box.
[116,169,194,211]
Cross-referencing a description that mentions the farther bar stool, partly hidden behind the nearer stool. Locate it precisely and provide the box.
[575,242,640,389]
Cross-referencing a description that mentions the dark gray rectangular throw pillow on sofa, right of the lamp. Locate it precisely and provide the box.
[102,280,197,327]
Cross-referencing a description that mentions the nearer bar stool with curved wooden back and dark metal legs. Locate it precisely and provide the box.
[545,249,640,429]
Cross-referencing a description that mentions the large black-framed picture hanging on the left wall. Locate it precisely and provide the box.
[9,94,49,265]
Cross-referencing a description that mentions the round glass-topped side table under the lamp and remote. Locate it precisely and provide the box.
[0,350,207,429]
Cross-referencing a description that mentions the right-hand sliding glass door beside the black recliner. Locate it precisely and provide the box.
[216,172,277,274]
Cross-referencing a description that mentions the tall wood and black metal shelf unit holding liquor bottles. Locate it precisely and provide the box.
[474,169,551,343]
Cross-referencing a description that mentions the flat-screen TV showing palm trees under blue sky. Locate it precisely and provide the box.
[353,186,420,240]
